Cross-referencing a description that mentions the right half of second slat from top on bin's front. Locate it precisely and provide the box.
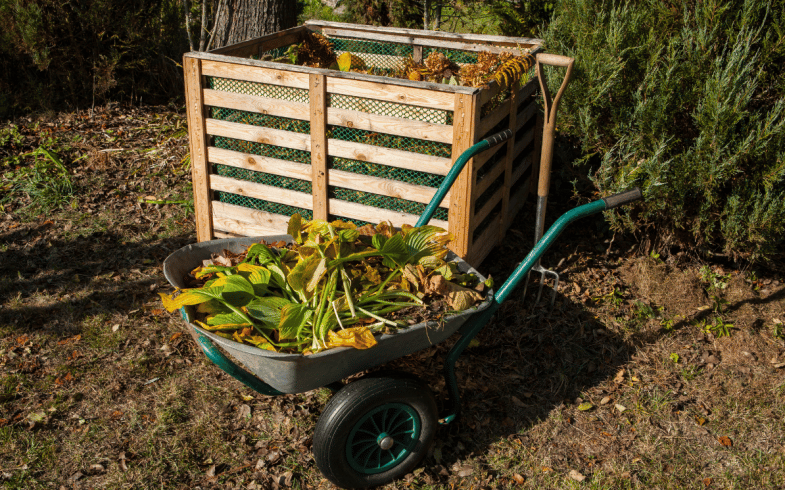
[327,107,452,143]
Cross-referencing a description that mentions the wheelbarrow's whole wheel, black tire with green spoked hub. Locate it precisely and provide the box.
[313,373,438,488]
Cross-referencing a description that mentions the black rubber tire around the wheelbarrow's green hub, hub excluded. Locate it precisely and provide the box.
[313,373,438,488]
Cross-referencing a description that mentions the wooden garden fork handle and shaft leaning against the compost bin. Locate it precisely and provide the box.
[535,53,575,243]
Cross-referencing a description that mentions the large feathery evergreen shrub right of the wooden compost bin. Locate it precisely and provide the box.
[543,0,785,260]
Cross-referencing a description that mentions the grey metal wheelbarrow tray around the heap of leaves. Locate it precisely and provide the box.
[164,235,492,393]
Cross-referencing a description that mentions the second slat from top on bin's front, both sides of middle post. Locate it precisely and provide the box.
[204,89,452,143]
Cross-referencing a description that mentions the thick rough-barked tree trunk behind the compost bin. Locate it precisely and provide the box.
[211,0,297,49]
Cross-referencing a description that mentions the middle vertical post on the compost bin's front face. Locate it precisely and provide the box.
[309,73,330,220]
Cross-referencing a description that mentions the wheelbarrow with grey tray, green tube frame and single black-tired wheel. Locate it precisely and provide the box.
[164,130,641,488]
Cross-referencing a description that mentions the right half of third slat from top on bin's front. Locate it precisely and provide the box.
[327,139,452,175]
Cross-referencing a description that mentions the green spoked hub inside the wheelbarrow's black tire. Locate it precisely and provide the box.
[346,403,422,475]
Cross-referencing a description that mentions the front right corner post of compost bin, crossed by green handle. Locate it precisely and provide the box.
[449,94,480,259]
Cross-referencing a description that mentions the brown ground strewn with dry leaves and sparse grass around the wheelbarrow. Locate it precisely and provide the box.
[0,107,785,489]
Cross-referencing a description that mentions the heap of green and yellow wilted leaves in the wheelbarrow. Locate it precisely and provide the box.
[161,215,491,354]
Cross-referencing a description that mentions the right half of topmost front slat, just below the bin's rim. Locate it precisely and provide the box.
[327,77,455,111]
